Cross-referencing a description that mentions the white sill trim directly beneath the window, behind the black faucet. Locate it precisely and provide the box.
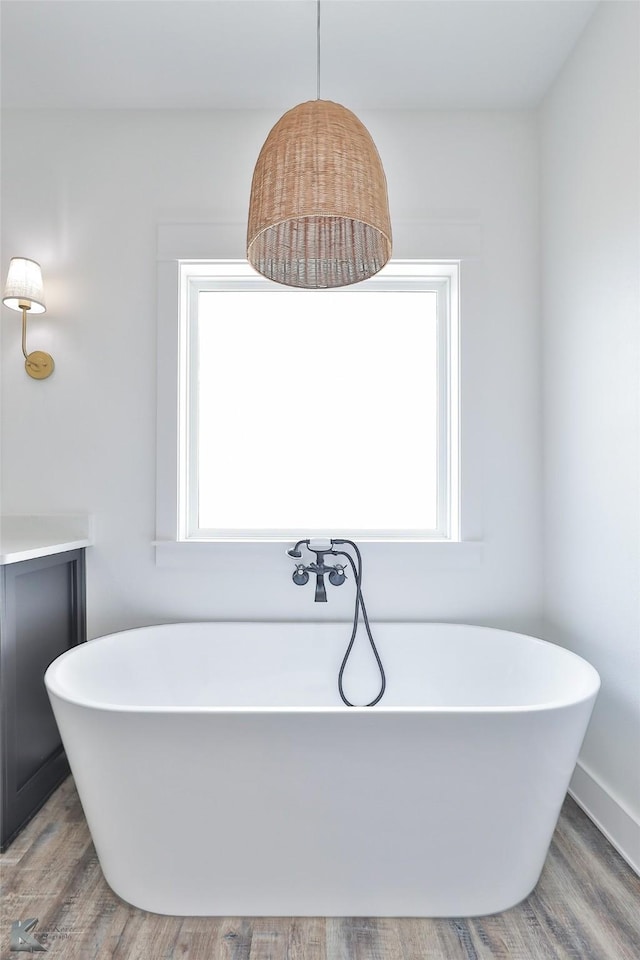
[153,538,484,570]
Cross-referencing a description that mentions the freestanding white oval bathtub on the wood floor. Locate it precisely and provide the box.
[45,623,600,917]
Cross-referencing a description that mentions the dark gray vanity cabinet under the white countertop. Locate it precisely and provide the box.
[0,549,86,850]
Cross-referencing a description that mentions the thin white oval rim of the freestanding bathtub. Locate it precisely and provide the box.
[44,620,602,716]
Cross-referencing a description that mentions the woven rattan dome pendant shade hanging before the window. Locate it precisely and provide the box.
[247,100,391,289]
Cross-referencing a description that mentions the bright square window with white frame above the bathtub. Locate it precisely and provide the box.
[164,261,458,540]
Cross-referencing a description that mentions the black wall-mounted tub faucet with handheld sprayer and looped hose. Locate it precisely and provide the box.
[287,537,387,707]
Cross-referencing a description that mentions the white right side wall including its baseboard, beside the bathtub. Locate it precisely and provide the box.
[541,3,640,865]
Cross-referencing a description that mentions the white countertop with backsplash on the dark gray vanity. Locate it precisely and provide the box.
[0,514,93,565]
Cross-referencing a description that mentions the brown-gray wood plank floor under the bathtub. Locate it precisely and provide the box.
[0,778,640,960]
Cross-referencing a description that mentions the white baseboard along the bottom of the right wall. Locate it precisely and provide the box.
[569,761,640,876]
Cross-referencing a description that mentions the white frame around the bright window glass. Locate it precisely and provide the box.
[156,259,460,543]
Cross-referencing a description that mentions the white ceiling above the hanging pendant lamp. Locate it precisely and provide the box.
[0,0,597,109]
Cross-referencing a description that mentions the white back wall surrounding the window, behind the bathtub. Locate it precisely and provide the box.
[2,104,541,636]
